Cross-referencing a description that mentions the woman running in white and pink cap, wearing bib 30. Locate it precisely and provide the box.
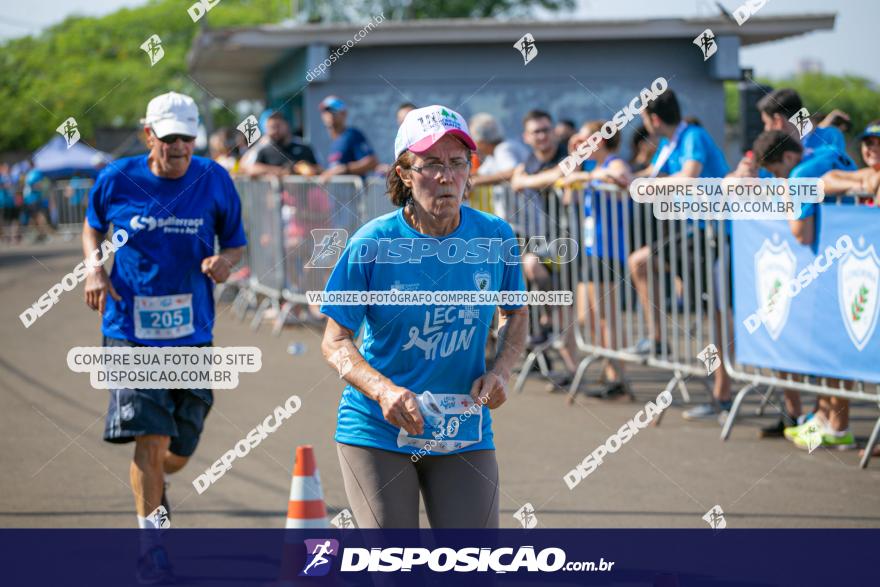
[321,105,528,528]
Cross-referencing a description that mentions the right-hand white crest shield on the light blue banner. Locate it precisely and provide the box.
[837,238,880,351]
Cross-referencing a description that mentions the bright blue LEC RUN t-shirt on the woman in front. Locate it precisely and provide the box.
[321,206,525,454]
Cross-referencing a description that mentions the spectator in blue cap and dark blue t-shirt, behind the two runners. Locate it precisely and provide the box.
[320,96,379,180]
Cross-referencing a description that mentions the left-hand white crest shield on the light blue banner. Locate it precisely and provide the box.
[755,235,797,340]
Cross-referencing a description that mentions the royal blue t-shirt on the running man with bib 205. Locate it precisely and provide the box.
[86,155,247,346]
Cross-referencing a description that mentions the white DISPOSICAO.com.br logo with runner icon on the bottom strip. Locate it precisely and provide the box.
[300,538,615,577]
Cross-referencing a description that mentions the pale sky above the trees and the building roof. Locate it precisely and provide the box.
[0,0,880,84]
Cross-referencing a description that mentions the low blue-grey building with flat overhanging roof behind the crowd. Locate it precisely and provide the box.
[189,14,835,162]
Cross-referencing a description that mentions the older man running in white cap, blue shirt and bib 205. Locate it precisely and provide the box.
[83,92,246,583]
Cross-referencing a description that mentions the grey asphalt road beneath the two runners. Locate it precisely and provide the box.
[0,242,880,528]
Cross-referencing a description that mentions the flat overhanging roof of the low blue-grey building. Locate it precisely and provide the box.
[188,13,835,100]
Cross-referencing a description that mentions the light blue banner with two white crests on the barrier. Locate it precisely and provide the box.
[731,205,880,382]
